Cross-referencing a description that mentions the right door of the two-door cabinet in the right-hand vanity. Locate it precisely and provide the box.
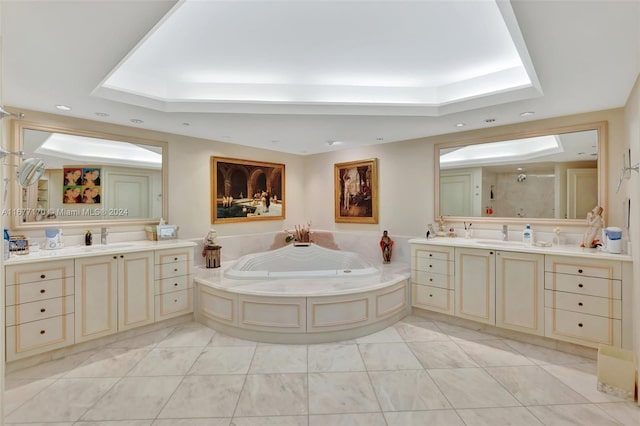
[496,251,544,336]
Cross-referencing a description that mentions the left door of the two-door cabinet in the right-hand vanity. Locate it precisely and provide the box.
[455,248,496,324]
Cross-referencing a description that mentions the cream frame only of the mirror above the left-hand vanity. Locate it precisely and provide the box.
[9,120,169,230]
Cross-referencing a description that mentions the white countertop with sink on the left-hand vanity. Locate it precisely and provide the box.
[4,240,196,266]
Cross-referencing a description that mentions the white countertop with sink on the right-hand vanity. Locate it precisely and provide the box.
[409,237,633,262]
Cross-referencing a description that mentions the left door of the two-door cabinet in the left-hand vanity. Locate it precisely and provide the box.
[75,255,118,343]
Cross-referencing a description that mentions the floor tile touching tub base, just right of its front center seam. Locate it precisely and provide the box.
[308,343,365,372]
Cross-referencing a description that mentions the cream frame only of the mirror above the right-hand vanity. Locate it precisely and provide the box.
[433,121,609,226]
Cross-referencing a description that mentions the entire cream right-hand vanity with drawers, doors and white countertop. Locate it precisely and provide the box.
[409,238,633,348]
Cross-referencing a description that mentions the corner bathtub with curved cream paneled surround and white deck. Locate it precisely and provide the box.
[194,244,411,344]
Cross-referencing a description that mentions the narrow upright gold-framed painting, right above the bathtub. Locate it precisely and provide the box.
[334,158,378,223]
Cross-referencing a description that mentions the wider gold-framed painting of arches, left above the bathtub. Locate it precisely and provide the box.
[211,157,285,223]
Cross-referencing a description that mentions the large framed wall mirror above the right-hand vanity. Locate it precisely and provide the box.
[435,122,607,224]
